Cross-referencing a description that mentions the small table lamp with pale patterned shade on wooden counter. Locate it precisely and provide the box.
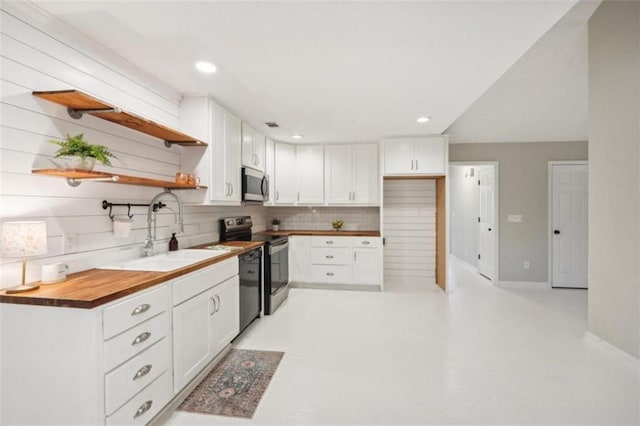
[2,222,47,294]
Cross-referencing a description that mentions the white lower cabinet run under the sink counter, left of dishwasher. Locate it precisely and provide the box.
[0,258,239,425]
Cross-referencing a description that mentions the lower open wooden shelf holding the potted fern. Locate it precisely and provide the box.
[31,169,206,189]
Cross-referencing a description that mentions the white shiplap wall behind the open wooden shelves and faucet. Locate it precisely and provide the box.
[0,2,265,287]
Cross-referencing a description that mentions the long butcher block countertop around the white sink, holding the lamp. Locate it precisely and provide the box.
[0,241,263,309]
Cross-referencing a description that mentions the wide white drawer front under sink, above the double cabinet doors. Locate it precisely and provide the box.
[172,257,238,306]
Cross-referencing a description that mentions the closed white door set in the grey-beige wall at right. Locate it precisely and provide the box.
[551,164,588,288]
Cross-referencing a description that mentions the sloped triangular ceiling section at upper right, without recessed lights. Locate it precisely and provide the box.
[446,1,600,143]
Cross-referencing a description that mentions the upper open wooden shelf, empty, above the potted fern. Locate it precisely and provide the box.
[33,90,207,146]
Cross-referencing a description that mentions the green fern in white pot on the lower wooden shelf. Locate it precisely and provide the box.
[49,133,116,170]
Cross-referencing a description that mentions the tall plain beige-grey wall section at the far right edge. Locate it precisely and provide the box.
[589,1,640,358]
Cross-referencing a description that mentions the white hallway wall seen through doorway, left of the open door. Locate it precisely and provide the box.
[447,165,478,266]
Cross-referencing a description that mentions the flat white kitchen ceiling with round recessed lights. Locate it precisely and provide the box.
[35,0,586,142]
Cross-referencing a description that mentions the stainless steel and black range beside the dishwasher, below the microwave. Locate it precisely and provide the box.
[220,216,289,315]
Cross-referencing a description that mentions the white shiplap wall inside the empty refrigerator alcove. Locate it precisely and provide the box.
[383,180,436,284]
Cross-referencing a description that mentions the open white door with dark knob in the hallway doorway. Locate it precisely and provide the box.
[477,166,496,280]
